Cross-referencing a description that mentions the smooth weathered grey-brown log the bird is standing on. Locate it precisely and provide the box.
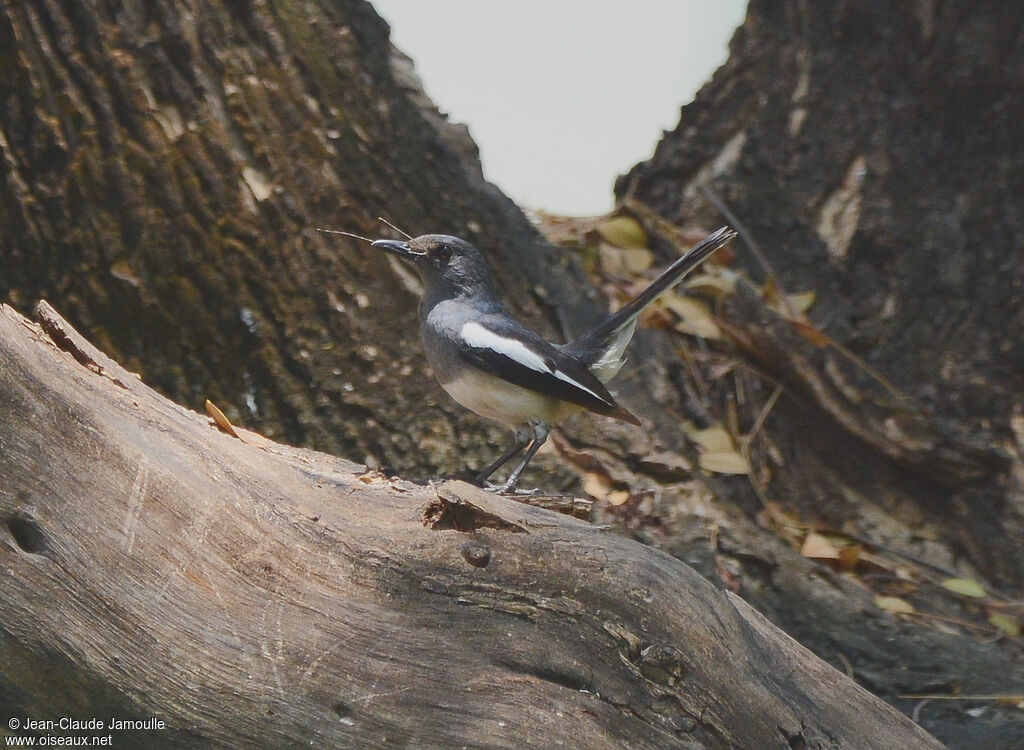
[0,306,940,750]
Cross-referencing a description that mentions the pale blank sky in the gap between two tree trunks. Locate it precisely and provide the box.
[372,0,746,215]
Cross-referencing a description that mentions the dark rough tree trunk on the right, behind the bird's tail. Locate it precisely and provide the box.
[617,0,1024,592]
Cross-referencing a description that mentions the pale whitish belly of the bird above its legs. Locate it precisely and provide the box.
[441,368,581,428]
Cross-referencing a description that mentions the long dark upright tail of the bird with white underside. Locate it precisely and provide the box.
[565,226,736,382]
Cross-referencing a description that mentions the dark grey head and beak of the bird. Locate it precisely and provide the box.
[373,235,493,301]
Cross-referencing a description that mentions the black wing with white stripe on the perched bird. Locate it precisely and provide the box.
[457,316,640,424]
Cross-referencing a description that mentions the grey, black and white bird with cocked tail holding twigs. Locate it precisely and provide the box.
[352,226,736,494]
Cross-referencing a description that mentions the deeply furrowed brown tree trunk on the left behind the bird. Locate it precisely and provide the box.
[0,0,583,475]
